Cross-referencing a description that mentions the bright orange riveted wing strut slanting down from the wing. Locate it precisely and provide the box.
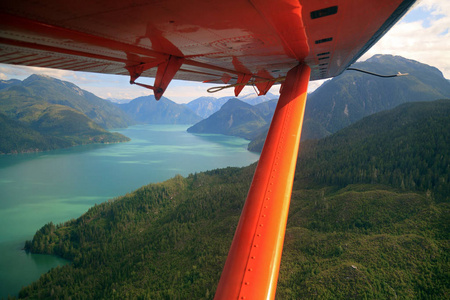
[214,65,311,300]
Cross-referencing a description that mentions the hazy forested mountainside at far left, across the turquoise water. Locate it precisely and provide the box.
[0,75,133,154]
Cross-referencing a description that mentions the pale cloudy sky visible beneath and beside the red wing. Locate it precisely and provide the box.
[0,0,450,103]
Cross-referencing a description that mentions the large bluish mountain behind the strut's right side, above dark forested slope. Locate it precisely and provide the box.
[249,55,450,152]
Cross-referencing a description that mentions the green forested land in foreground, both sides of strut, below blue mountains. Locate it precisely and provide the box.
[19,100,450,299]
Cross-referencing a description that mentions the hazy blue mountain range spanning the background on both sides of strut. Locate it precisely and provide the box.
[0,55,450,153]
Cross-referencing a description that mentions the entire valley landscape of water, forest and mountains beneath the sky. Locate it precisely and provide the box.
[0,55,450,299]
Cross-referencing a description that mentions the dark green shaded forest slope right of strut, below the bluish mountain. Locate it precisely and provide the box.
[299,100,450,202]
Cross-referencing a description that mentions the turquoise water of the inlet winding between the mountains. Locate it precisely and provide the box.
[0,125,259,298]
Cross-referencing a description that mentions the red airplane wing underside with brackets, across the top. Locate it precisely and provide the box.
[0,0,413,98]
